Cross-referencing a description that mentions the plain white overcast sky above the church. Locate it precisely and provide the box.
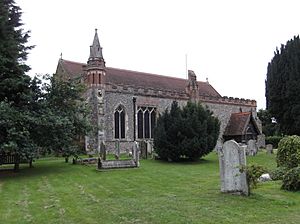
[16,0,300,109]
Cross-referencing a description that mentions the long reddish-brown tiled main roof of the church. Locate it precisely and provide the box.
[59,59,221,97]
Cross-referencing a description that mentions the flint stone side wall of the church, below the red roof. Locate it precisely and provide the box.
[91,85,256,152]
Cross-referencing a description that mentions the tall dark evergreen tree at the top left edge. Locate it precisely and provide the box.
[0,0,32,106]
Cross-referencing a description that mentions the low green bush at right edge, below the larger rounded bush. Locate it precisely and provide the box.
[281,167,300,191]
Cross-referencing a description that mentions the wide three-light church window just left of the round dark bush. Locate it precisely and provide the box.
[137,107,156,138]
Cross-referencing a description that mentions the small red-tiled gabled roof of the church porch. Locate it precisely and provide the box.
[224,112,260,136]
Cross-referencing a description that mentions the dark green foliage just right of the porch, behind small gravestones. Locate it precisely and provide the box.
[257,109,280,136]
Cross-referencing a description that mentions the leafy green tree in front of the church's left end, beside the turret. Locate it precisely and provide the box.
[35,75,91,162]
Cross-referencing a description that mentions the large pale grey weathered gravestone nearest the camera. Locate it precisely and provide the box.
[218,140,249,195]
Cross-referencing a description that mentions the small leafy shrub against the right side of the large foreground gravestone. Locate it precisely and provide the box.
[240,164,268,190]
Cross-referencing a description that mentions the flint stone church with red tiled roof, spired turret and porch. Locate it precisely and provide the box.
[56,30,261,152]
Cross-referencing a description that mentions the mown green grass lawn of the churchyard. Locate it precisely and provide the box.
[0,152,300,224]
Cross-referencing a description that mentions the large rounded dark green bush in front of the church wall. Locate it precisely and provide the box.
[154,101,220,161]
